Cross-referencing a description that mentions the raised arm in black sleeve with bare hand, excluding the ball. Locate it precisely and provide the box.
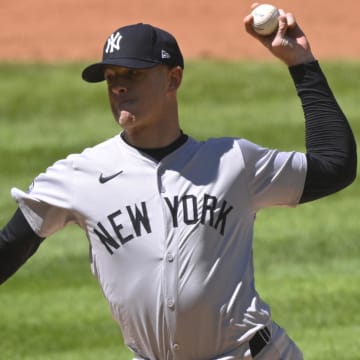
[244,4,357,202]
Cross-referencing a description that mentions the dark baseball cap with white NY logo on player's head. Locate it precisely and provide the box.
[82,23,184,82]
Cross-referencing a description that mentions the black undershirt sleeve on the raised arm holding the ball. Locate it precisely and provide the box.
[289,61,357,203]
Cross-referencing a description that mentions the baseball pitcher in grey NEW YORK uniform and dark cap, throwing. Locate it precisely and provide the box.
[0,4,357,360]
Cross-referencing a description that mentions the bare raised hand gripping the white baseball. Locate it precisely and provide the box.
[244,3,315,66]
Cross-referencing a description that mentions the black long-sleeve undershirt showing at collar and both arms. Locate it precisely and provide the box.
[0,61,357,284]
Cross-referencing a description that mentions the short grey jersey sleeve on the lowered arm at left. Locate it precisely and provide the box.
[11,156,76,237]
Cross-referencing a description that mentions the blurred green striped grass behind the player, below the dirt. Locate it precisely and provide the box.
[0,61,360,360]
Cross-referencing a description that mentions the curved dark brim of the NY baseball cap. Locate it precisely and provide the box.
[81,58,160,82]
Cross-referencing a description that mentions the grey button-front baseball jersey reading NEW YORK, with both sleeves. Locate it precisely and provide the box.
[12,135,306,360]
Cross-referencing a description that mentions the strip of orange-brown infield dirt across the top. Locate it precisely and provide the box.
[0,0,360,61]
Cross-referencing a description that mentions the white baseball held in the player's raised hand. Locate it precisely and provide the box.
[251,4,280,35]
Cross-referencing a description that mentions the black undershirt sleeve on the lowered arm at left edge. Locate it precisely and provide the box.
[0,208,43,284]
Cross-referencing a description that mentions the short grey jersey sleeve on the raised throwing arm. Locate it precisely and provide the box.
[239,139,307,211]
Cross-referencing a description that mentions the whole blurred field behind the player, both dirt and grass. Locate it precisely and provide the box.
[0,0,360,360]
